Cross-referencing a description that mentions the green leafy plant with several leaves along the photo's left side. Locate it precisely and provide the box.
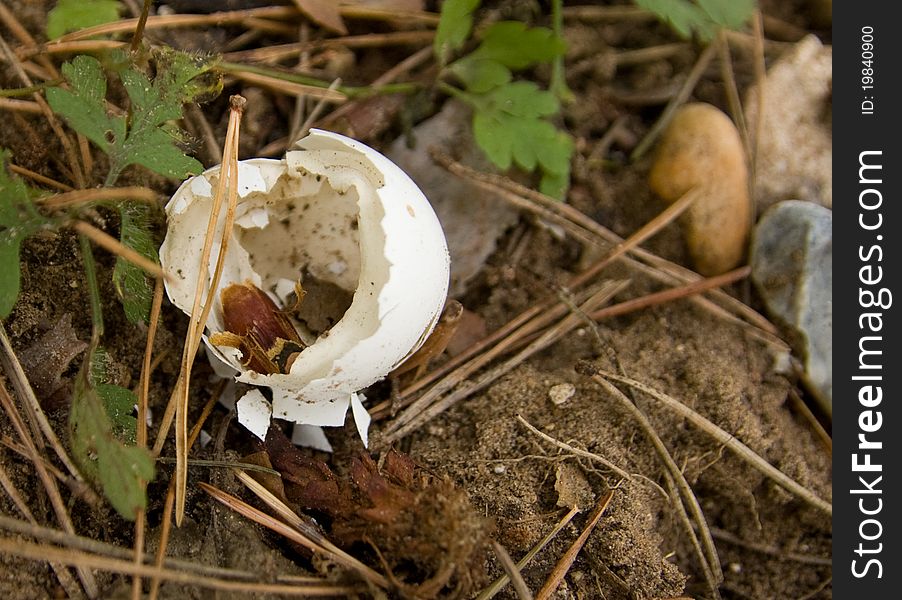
[0,48,219,519]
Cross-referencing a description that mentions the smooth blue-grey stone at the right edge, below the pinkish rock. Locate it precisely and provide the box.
[751,200,833,414]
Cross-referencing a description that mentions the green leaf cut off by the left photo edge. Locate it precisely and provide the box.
[0,150,50,319]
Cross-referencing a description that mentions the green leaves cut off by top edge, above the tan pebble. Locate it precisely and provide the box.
[635,0,755,41]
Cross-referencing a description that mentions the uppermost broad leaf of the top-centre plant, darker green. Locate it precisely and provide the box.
[470,21,566,69]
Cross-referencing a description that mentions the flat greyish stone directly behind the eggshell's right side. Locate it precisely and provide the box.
[386,101,519,297]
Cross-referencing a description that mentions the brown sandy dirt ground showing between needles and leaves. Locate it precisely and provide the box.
[0,2,831,600]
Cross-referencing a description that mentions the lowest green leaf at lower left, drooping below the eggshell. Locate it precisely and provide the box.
[69,358,154,520]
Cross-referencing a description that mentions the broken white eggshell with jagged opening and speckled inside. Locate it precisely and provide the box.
[160,130,449,443]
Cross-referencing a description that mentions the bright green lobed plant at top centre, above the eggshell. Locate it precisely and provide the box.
[434,0,573,198]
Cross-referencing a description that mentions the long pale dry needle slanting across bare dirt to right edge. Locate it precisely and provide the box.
[592,371,833,516]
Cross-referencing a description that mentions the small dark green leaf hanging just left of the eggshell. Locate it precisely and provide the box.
[113,203,157,323]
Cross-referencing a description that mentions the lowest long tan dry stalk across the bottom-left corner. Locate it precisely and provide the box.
[0,538,360,598]
